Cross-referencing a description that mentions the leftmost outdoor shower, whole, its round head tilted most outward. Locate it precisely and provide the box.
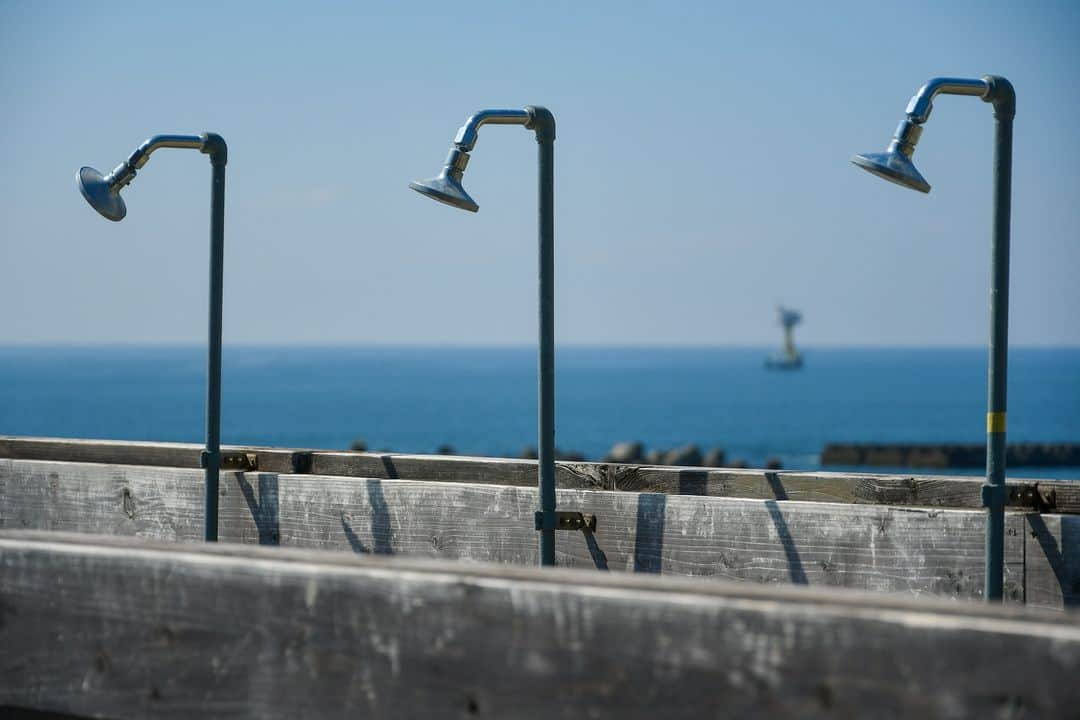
[76,133,234,542]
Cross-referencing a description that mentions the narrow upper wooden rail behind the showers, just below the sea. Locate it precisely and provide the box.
[0,437,1080,513]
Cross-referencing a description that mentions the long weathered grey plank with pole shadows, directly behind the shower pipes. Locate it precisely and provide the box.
[0,460,1025,602]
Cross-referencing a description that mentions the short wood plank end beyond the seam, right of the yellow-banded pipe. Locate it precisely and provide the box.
[1024,514,1080,608]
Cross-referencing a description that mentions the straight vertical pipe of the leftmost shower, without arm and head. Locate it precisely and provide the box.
[203,152,225,542]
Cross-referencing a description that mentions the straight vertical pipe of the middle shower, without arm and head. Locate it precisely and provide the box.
[537,132,555,566]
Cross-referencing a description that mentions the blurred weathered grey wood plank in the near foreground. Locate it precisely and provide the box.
[0,531,1080,720]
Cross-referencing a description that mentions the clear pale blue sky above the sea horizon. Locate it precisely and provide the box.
[0,0,1080,345]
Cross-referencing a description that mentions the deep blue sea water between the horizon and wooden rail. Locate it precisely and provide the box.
[0,347,1080,478]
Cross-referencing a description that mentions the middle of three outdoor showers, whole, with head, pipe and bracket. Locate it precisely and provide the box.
[409,106,595,565]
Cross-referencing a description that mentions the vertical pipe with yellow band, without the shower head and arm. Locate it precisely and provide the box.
[984,106,1014,602]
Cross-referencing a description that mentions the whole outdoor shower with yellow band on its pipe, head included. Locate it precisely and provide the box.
[851,76,1016,601]
